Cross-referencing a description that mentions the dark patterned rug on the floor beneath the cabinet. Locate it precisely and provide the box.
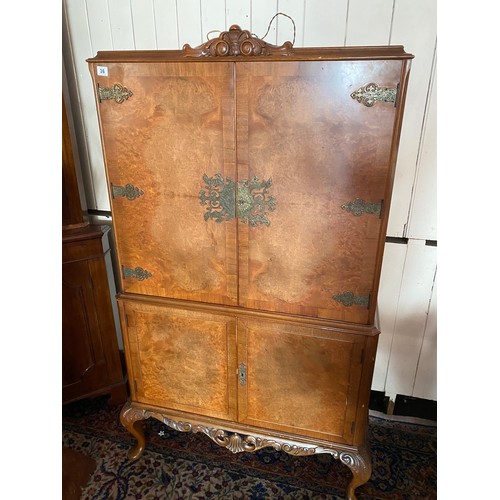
[62,398,437,500]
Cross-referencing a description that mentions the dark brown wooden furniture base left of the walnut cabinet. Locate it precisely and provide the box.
[62,226,125,402]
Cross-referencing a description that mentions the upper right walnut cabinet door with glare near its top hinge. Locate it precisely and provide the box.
[236,60,402,323]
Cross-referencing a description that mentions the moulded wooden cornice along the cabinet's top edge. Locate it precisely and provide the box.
[86,45,414,63]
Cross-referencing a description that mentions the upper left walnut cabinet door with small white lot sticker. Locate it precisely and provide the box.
[91,62,237,304]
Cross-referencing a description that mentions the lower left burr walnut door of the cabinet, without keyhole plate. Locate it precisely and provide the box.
[119,300,236,420]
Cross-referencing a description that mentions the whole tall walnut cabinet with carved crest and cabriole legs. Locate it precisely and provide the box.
[89,26,413,498]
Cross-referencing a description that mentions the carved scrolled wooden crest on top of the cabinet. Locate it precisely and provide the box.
[182,24,293,57]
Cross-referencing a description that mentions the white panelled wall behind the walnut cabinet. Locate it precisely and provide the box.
[63,0,437,400]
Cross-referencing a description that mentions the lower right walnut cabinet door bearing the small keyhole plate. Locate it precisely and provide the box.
[238,319,365,444]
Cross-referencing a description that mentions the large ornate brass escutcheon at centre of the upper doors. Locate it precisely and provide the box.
[198,174,276,226]
